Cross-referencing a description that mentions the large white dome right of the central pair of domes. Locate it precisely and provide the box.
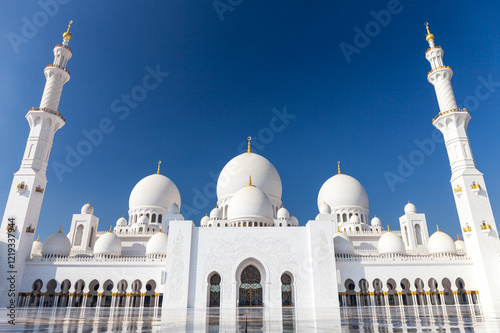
[318,174,369,210]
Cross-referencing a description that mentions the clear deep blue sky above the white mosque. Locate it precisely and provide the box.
[0,0,500,240]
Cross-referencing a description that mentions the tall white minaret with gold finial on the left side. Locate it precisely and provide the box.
[0,21,73,303]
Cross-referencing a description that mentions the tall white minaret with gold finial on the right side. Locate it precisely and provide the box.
[425,24,500,315]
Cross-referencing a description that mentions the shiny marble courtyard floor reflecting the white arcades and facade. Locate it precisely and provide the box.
[0,306,500,333]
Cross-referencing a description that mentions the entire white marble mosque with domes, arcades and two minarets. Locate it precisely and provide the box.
[0,25,500,328]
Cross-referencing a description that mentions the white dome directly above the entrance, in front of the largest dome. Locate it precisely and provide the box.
[227,185,273,221]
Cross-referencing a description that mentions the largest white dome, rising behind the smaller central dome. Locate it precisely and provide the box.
[217,153,282,201]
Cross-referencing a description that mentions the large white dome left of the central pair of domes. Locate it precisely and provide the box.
[128,174,181,209]
